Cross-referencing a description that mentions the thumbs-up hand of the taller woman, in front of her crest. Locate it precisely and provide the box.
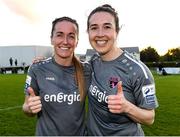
[108,81,129,113]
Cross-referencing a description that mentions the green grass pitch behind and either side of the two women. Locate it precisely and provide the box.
[0,74,180,136]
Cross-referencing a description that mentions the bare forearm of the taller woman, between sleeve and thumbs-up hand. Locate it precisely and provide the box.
[127,102,155,125]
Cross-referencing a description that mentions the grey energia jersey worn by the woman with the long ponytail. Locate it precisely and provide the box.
[25,58,90,136]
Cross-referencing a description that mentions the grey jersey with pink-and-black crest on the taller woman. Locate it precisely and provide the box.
[87,52,158,136]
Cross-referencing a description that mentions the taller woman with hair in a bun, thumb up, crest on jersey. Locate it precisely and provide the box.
[87,4,158,136]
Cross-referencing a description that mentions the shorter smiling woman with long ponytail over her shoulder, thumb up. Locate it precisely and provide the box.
[23,16,90,136]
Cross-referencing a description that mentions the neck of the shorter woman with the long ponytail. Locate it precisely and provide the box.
[54,55,73,66]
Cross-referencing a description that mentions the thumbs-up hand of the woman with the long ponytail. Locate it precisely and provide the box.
[27,87,42,114]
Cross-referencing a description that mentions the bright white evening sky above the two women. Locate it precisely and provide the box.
[0,0,180,55]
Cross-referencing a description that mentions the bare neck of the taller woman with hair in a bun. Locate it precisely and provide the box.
[101,46,123,61]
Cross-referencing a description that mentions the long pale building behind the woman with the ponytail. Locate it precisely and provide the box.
[0,45,53,68]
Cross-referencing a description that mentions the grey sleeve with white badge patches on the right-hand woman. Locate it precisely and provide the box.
[133,64,158,109]
